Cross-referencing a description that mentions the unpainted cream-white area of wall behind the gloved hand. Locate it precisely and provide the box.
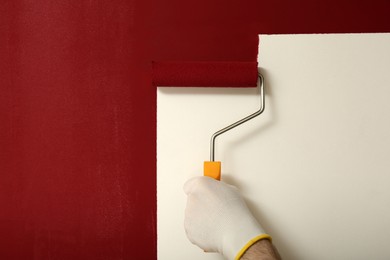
[157,34,390,260]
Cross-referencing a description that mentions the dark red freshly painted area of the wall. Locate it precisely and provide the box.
[0,0,390,259]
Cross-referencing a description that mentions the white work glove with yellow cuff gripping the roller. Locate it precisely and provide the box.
[184,176,271,260]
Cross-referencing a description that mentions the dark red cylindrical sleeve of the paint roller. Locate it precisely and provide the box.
[152,62,258,88]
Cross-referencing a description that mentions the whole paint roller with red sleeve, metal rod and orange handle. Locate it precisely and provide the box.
[152,61,265,180]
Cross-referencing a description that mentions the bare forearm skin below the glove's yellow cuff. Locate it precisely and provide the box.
[240,239,281,260]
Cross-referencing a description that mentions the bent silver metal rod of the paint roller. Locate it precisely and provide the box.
[210,74,265,162]
